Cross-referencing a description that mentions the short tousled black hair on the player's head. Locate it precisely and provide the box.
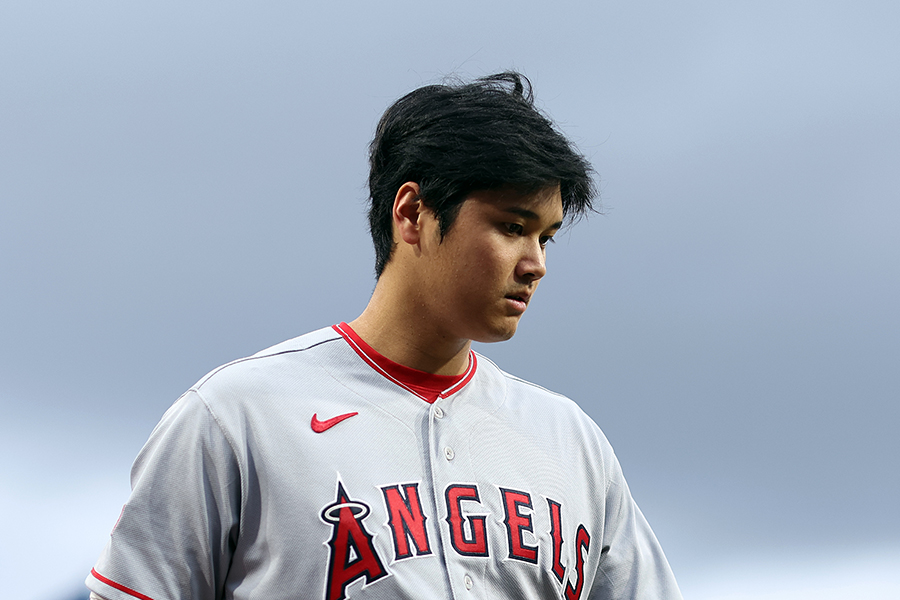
[369,72,597,277]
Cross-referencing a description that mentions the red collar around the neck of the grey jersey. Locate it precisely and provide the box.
[332,323,478,404]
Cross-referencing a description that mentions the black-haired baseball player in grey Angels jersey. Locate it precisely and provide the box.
[87,73,680,600]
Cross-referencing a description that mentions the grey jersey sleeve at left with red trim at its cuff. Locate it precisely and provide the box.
[86,391,242,600]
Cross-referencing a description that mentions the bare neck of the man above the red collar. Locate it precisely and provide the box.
[349,277,471,375]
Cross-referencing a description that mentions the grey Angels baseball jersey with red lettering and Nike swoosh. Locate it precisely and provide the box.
[87,324,681,600]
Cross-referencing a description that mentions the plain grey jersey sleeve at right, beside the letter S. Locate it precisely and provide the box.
[588,454,682,600]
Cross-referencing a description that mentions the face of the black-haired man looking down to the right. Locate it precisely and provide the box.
[419,186,563,342]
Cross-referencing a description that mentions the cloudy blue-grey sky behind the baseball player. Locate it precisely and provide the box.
[0,0,900,600]
